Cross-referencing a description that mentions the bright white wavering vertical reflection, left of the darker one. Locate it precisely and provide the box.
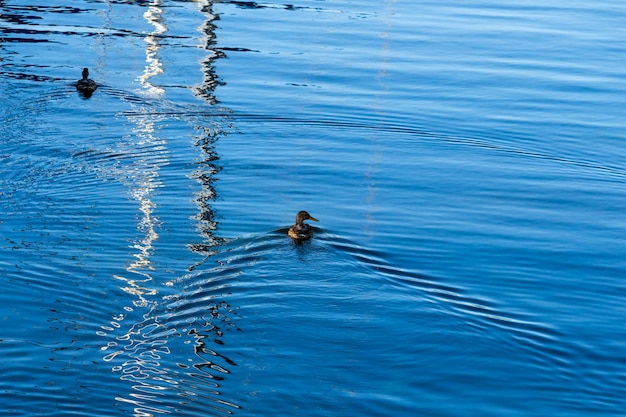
[101,0,173,416]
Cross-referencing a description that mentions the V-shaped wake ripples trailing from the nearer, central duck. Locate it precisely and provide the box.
[189,228,562,350]
